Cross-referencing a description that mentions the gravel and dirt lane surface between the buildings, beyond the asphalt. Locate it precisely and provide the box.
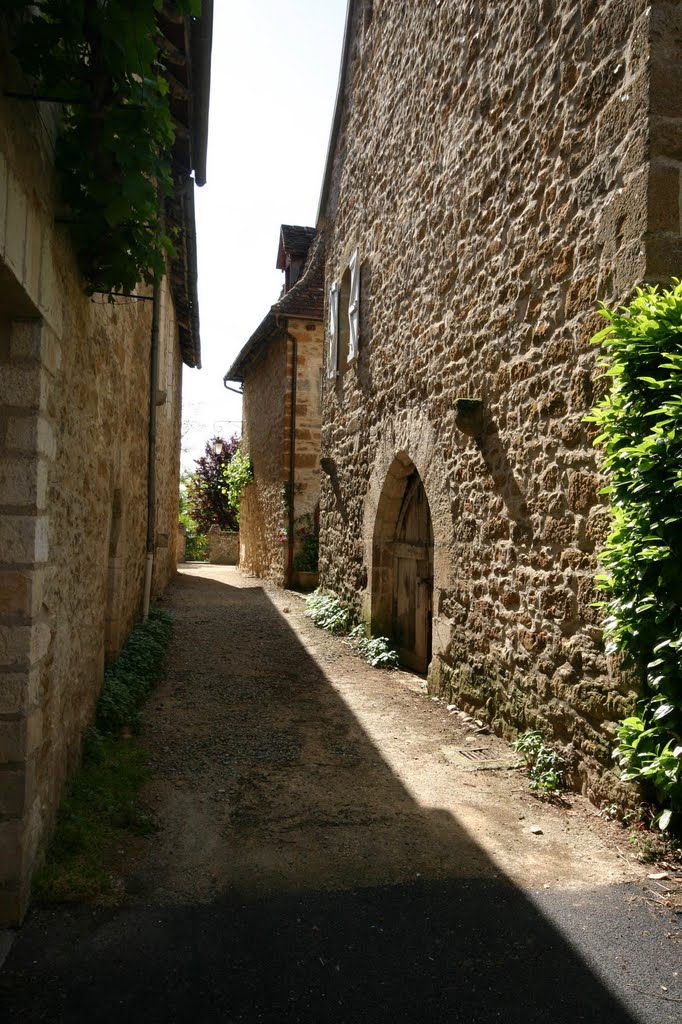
[115,564,651,905]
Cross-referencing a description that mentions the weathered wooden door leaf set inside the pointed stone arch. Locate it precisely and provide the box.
[391,469,433,672]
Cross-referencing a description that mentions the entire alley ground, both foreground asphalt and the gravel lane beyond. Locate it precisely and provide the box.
[0,564,682,1024]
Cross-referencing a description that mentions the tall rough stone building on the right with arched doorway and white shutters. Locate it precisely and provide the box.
[317,0,682,799]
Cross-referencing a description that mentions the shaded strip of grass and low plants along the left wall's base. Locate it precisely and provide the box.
[33,609,173,902]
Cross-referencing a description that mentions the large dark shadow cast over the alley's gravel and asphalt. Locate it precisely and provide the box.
[0,570,672,1024]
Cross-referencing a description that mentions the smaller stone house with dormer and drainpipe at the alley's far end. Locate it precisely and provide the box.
[224,224,325,587]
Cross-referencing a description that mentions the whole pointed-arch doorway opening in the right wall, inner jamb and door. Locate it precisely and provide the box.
[372,454,433,672]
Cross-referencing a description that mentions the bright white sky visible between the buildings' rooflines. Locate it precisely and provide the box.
[182,0,346,470]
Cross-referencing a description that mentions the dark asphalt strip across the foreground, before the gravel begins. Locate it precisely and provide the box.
[0,882,682,1024]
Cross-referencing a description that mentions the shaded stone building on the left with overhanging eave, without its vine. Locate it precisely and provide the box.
[0,3,211,923]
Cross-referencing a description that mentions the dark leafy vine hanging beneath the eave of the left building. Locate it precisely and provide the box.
[0,0,201,293]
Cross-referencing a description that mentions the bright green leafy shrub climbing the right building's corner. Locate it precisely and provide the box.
[590,281,682,828]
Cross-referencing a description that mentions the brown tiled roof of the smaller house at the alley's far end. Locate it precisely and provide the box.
[223,232,325,383]
